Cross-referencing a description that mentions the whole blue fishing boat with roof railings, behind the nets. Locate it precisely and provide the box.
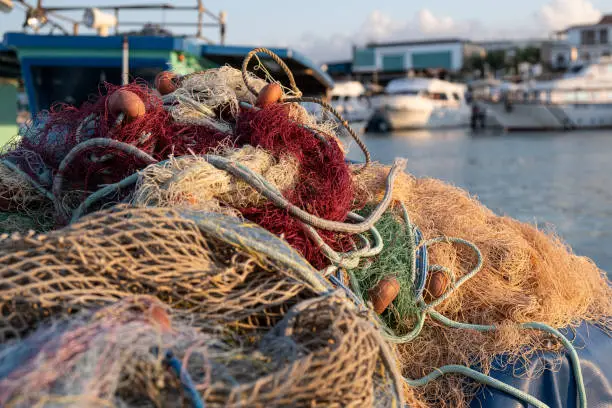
[0,0,334,135]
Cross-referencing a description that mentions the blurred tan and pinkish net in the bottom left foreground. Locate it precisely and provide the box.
[0,296,402,407]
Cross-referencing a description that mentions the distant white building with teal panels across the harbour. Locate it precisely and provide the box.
[353,38,486,83]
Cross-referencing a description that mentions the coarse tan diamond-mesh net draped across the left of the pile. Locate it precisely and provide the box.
[0,206,326,339]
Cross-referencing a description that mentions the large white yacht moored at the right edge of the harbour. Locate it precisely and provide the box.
[484,57,612,130]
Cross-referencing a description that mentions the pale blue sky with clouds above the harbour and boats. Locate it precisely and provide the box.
[0,0,612,63]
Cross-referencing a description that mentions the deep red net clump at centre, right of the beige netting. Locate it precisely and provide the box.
[236,106,353,268]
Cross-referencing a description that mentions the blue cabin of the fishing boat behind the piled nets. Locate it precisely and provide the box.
[3,33,333,118]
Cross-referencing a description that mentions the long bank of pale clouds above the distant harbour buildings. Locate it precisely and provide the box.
[293,0,602,62]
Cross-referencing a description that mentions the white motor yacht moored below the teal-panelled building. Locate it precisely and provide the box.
[369,78,471,131]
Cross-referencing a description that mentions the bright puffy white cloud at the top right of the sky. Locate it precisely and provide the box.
[536,0,601,31]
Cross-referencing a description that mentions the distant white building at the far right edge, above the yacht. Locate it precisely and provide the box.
[550,14,612,68]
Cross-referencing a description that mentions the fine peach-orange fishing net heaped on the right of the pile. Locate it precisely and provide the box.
[355,166,612,407]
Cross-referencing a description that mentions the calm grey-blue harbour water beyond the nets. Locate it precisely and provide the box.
[340,129,612,276]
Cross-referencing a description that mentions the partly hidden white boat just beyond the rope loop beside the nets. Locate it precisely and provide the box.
[331,81,373,122]
